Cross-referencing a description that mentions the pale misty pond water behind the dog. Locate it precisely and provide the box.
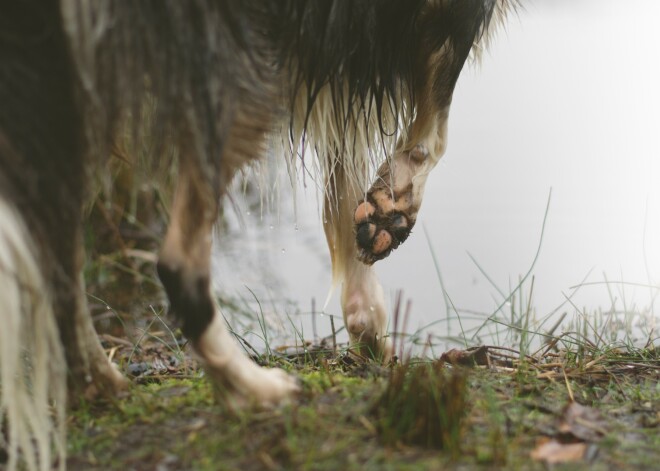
[214,0,660,352]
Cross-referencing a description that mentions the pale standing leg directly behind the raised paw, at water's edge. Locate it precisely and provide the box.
[324,164,392,362]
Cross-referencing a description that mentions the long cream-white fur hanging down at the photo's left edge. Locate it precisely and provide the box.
[0,199,66,471]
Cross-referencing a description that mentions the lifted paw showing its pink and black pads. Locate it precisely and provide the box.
[353,145,429,265]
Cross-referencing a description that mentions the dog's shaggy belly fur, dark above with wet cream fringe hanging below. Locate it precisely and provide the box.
[62,0,517,192]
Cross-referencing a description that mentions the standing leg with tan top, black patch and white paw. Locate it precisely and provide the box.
[158,134,298,406]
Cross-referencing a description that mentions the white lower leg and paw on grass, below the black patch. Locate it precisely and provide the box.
[195,311,300,407]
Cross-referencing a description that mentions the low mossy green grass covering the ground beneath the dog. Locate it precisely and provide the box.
[64,334,660,470]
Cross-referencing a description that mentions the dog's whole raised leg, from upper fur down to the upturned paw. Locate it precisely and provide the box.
[353,1,484,264]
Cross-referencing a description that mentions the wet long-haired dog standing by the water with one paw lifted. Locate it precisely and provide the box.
[0,0,516,470]
